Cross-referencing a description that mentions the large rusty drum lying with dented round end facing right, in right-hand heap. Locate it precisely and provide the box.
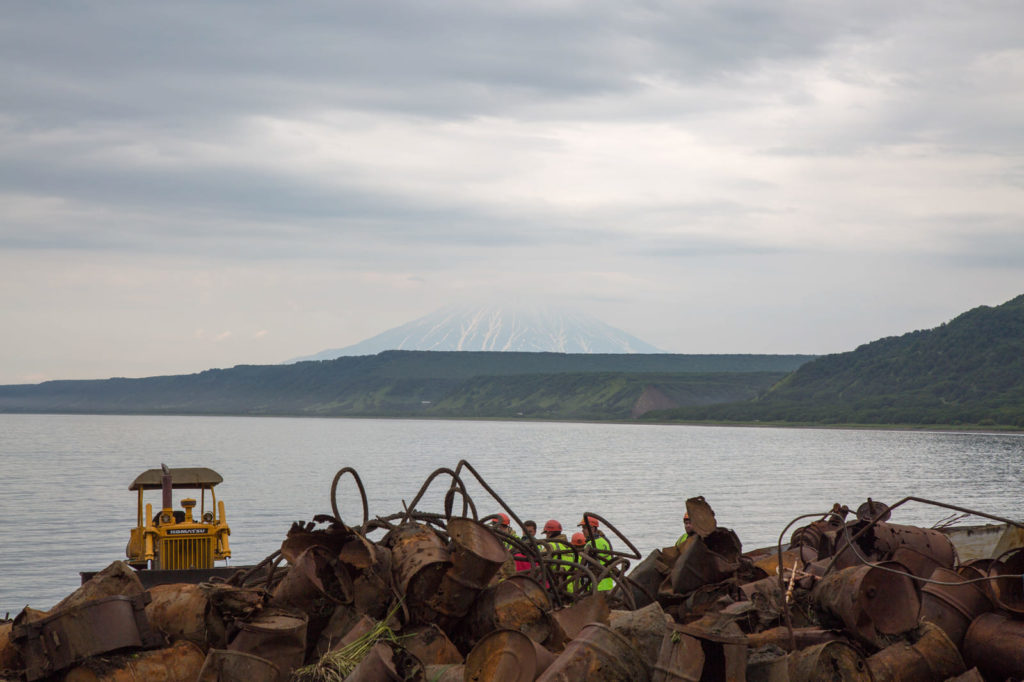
[811,562,921,646]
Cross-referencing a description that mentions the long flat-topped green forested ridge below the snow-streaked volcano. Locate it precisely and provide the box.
[0,351,813,419]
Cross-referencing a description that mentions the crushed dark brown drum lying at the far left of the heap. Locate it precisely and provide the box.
[11,592,163,682]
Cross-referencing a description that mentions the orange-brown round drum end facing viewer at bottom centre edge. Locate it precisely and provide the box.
[465,630,555,682]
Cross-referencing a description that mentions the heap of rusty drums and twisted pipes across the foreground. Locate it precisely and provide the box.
[0,462,1024,682]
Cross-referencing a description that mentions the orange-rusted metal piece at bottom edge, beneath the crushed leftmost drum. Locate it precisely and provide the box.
[61,640,207,682]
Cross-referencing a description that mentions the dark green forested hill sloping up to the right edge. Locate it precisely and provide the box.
[648,296,1024,427]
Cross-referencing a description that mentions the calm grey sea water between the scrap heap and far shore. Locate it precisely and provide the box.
[0,415,1024,617]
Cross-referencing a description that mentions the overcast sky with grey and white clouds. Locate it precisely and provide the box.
[0,0,1024,383]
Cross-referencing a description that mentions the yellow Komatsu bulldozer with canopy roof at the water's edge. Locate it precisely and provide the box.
[126,465,231,570]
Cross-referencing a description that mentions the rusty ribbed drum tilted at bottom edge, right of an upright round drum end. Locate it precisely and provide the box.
[537,623,650,682]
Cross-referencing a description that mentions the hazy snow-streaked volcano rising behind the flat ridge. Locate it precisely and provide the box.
[290,305,664,363]
